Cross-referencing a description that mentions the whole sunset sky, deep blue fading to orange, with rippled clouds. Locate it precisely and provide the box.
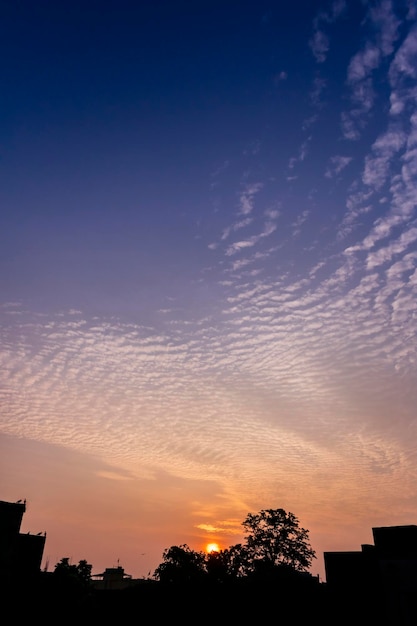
[0,0,417,579]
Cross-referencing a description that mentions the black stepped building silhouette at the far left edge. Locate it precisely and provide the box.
[0,500,46,580]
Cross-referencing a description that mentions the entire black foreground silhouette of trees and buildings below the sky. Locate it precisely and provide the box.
[0,500,417,626]
